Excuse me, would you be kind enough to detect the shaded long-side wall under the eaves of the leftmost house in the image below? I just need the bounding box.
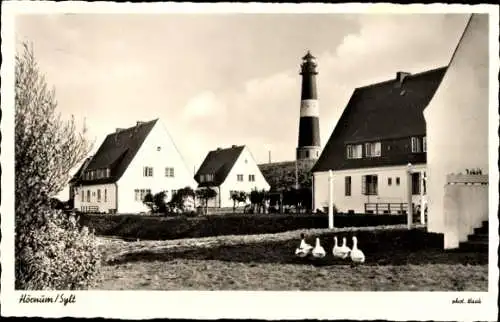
[74,183,116,213]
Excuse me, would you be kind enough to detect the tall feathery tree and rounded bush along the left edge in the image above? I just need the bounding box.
[14,43,100,290]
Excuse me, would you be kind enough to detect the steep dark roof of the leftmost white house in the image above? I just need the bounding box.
[72,119,158,185]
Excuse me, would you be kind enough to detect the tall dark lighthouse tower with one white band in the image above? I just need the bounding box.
[297,51,321,160]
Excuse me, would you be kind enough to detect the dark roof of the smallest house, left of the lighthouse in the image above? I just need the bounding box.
[194,145,245,187]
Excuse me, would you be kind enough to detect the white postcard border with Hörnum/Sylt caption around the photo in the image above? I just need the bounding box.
[0,1,499,321]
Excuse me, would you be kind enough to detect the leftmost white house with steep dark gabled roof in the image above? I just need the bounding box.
[70,119,196,213]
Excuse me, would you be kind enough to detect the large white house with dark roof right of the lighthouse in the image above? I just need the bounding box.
[311,67,446,214]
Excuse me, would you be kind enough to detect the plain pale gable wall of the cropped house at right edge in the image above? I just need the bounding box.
[424,14,490,248]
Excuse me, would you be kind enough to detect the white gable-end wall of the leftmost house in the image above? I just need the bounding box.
[118,122,196,213]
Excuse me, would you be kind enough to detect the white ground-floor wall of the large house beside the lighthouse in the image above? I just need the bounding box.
[313,164,426,213]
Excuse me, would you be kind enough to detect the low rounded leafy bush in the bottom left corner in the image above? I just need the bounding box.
[16,208,101,290]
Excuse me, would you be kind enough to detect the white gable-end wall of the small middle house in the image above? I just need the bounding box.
[220,147,270,207]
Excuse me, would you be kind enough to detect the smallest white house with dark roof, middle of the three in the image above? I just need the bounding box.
[195,145,270,208]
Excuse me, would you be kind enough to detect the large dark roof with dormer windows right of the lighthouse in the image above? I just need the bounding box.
[312,67,447,172]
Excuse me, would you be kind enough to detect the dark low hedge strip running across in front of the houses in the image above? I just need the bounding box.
[80,214,406,240]
